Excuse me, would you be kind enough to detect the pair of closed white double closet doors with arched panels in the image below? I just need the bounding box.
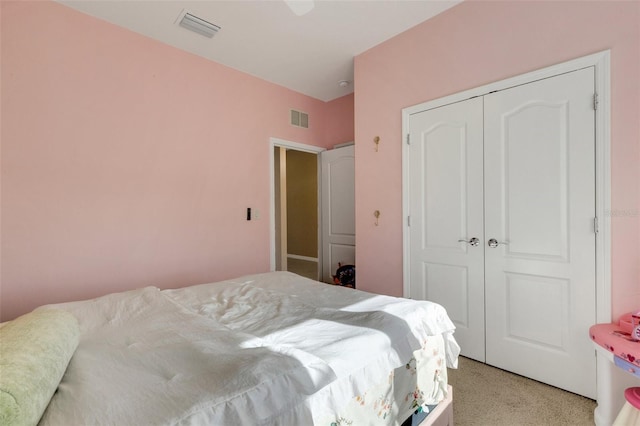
[408,67,596,398]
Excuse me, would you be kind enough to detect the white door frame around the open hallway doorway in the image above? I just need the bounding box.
[269,138,326,271]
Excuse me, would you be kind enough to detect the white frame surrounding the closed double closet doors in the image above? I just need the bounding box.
[402,50,612,322]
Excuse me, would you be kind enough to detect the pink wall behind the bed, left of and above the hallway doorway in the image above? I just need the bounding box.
[0,1,353,320]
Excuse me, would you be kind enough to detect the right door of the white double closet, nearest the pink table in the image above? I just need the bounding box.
[484,67,596,398]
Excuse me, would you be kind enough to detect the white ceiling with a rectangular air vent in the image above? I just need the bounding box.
[57,0,461,101]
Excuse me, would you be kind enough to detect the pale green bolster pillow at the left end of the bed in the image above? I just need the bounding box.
[0,309,80,425]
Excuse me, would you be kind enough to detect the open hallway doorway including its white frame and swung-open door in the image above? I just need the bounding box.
[270,138,355,283]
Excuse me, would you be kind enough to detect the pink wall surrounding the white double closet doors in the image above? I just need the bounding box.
[355,1,640,317]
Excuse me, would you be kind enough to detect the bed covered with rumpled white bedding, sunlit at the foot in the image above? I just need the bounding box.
[0,272,459,426]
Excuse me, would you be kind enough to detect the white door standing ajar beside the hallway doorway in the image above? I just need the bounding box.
[320,145,357,286]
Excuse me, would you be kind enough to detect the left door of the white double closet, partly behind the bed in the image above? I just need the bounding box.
[408,98,485,361]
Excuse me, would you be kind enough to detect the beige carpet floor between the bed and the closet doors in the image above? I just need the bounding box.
[448,357,596,426]
